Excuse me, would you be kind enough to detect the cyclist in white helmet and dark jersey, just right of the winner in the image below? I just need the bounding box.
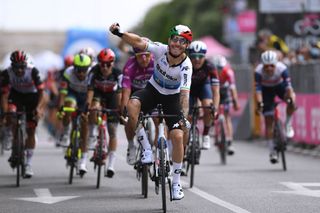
[188,41,220,149]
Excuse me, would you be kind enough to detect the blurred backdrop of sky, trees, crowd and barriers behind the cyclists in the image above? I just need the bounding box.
[0,0,320,147]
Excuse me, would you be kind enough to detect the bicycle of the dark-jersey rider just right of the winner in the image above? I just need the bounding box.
[185,101,215,188]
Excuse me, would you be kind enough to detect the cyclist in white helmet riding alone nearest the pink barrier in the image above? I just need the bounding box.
[255,50,296,163]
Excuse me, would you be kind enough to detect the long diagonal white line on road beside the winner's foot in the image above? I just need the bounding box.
[181,181,250,213]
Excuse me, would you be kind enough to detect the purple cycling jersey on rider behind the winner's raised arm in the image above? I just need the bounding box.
[122,56,154,90]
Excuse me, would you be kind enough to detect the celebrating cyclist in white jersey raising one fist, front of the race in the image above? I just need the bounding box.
[110,23,192,200]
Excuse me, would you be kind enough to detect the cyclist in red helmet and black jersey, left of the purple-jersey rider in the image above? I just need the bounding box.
[86,48,122,178]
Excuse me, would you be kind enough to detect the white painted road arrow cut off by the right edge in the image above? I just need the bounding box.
[274,182,320,197]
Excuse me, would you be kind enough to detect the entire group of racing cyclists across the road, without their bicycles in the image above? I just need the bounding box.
[0,23,295,200]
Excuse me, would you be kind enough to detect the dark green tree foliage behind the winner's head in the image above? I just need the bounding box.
[135,0,224,43]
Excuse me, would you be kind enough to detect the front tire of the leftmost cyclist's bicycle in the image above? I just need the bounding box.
[13,128,24,187]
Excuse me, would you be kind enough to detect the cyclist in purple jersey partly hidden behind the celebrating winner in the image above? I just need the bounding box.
[120,38,154,165]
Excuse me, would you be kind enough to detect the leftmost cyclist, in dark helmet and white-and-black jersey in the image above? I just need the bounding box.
[1,50,45,178]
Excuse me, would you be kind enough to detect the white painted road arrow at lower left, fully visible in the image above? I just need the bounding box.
[13,188,79,204]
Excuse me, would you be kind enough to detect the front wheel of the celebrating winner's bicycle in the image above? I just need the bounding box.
[159,138,167,212]
